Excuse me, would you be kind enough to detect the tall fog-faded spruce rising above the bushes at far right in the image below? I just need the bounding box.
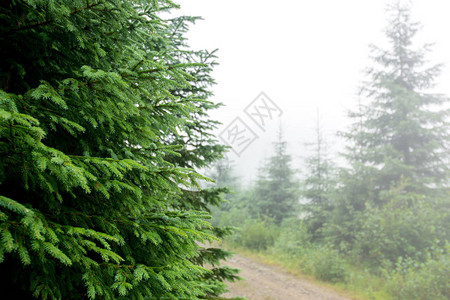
[346,2,449,201]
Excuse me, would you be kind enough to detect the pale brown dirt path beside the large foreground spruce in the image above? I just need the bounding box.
[224,254,351,300]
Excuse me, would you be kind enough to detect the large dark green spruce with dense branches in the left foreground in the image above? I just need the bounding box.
[0,0,239,299]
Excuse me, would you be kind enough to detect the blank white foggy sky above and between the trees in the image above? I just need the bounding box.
[177,0,450,181]
